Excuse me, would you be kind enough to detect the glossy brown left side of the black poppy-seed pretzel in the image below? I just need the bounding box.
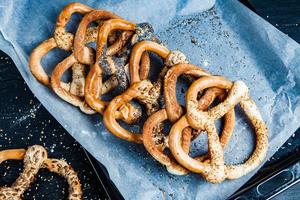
[85,19,154,113]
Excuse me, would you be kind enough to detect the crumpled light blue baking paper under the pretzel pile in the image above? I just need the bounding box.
[0,0,300,199]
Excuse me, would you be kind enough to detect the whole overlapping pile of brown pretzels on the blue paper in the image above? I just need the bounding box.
[29,3,268,183]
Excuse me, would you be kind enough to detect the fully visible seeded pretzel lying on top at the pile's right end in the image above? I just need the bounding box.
[169,76,268,182]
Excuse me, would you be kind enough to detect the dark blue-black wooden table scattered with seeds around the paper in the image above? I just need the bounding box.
[0,0,300,200]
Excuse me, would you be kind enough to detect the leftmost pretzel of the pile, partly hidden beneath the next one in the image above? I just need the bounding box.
[29,3,93,85]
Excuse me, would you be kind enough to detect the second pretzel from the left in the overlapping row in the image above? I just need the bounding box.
[51,10,136,114]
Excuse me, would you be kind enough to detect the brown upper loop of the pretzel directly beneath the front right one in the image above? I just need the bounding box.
[164,63,210,122]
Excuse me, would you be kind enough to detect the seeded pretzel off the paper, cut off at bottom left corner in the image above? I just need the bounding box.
[0,145,82,200]
